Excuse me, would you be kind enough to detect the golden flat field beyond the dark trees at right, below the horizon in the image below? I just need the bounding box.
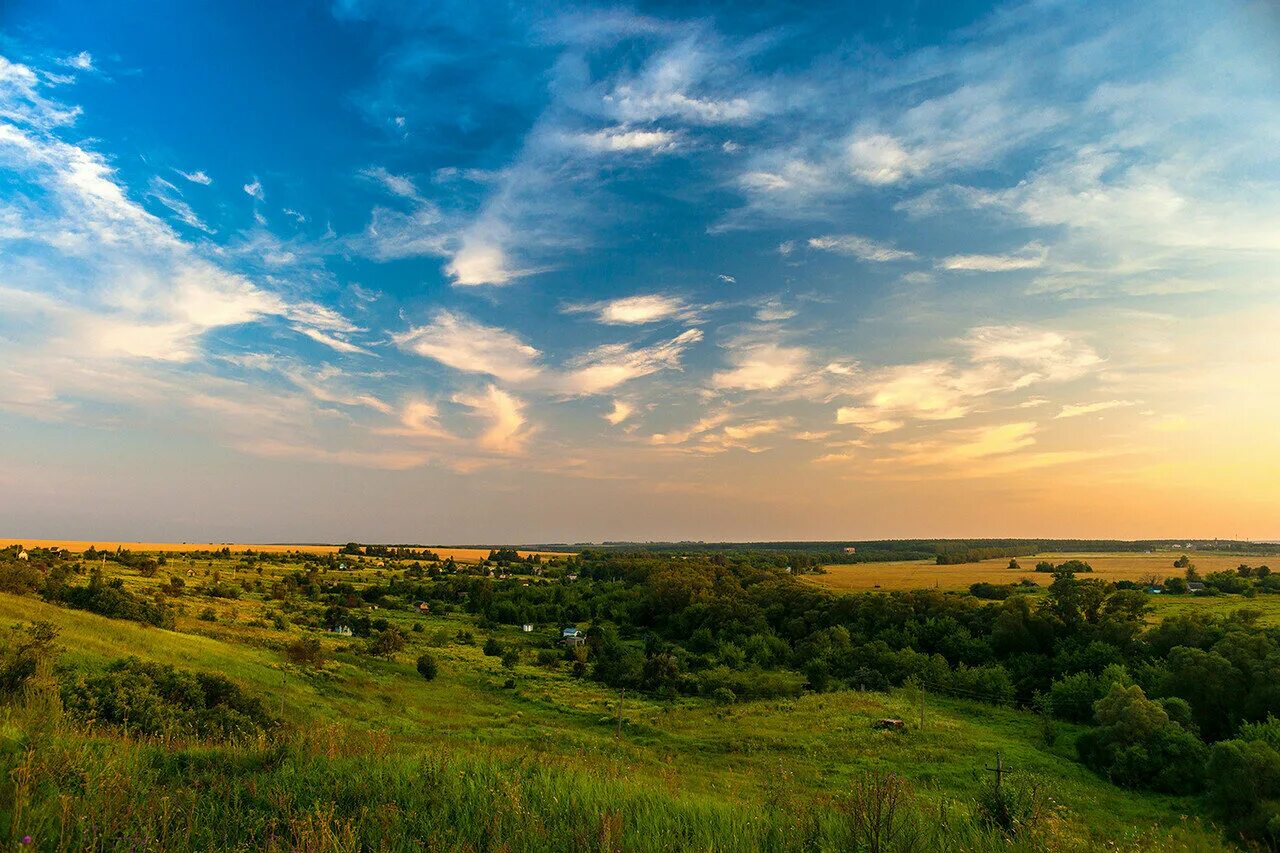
[801,551,1280,592]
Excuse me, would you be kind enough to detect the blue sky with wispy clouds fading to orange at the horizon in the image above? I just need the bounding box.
[0,0,1280,544]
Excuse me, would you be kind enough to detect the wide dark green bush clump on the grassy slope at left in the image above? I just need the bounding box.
[63,657,276,738]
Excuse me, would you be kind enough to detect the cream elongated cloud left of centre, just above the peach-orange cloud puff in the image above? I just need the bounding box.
[392,310,541,382]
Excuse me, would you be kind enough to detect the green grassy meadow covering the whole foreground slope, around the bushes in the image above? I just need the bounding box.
[0,540,1259,850]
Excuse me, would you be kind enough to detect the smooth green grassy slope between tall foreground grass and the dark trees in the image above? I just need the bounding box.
[0,589,1216,848]
